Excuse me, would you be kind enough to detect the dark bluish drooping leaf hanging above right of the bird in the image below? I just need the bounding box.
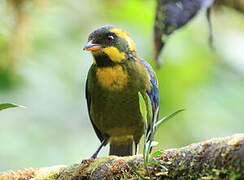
[154,0,216,67]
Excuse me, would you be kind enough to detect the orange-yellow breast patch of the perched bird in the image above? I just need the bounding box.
[96,65,128,91]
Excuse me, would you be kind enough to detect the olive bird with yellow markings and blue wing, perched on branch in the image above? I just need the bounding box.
[83,25,159,159]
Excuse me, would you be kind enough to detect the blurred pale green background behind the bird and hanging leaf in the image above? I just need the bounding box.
[0,0,244,171]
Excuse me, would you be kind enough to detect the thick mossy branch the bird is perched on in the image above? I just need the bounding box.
[0,134,244,180]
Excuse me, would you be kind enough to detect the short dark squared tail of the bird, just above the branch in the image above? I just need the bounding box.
[109,141,133,156]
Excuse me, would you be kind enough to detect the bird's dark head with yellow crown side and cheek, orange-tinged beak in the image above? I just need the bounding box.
[84,26,136,66]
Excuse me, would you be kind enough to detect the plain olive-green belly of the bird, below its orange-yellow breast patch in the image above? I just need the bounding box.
[92,92,144,137]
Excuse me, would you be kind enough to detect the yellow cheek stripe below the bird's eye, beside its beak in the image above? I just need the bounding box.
[102,46,126,62]
